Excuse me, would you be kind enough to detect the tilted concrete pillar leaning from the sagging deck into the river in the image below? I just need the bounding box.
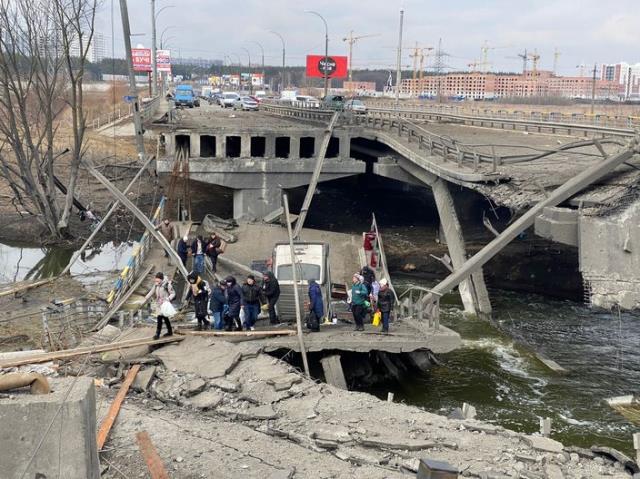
[430,178,491,315]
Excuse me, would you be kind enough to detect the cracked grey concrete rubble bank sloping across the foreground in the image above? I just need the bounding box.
[90,331,633,479]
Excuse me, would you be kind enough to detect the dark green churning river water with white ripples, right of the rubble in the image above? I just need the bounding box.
[378,280,640,454]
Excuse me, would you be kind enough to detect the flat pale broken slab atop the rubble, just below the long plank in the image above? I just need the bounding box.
[153,336,242,379]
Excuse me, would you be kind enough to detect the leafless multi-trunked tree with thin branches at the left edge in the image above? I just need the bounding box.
[0,0,97,237]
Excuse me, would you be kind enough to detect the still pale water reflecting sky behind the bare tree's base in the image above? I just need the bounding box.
[0,242,135,284]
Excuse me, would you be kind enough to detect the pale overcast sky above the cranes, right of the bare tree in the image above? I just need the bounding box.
[97,0,640,75]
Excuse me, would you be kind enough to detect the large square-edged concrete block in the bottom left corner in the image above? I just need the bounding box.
[0,376,100,479]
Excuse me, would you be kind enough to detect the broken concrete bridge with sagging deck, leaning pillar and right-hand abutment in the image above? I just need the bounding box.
[149,105,640,312]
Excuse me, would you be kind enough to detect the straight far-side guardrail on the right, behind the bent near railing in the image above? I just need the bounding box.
[368,107,634,137]
